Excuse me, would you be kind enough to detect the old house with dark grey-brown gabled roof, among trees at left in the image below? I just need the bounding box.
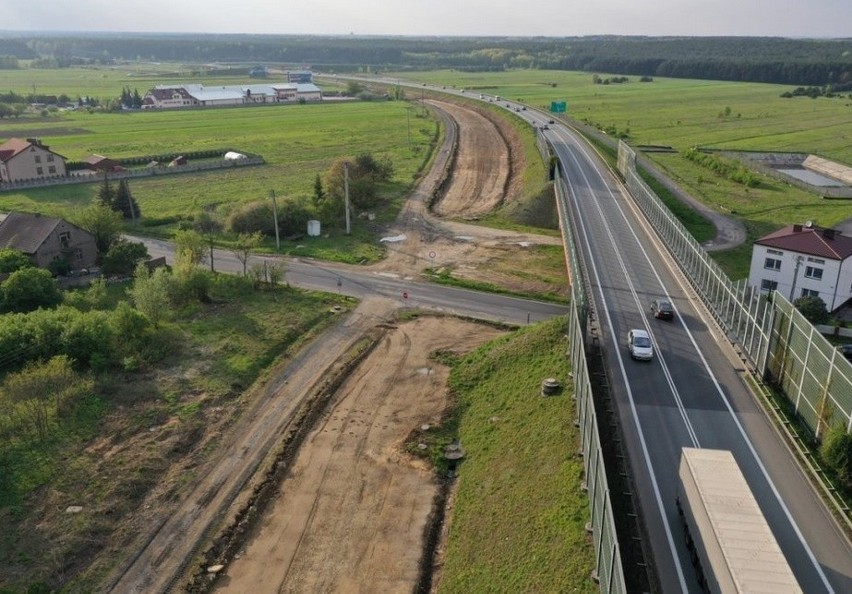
[0,212,98,270]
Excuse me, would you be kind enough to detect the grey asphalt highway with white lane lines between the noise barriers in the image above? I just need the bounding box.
[540,112,852,593]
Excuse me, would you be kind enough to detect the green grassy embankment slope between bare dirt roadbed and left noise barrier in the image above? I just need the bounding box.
[439,319,597,593]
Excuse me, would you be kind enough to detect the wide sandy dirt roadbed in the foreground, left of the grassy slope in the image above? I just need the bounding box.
[217,318,499,594]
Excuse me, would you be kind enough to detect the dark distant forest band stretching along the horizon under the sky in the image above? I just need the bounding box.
[0,32,852,90]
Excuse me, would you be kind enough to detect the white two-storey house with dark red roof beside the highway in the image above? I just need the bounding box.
[748,222,852,312]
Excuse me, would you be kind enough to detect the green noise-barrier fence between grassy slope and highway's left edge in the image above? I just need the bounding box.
[554,163,627,593]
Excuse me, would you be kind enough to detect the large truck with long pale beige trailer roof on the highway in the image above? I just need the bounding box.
[677,448,802,594]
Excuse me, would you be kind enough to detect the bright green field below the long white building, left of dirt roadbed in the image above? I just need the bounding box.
[0,102,437,222]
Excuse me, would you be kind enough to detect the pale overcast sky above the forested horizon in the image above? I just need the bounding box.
[5,0,852,37]
